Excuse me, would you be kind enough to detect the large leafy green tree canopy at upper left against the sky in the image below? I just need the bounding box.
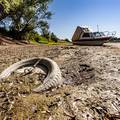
[0,0,52,39]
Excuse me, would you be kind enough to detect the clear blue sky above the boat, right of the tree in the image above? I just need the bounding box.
[49,0,120,39]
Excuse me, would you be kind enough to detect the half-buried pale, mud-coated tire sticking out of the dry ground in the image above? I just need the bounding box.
[0,57,63,92]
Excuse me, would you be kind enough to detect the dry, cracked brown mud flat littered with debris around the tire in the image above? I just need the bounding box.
[0,45,120,120]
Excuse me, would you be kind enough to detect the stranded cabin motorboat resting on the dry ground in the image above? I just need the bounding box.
[72,26,112,46]
